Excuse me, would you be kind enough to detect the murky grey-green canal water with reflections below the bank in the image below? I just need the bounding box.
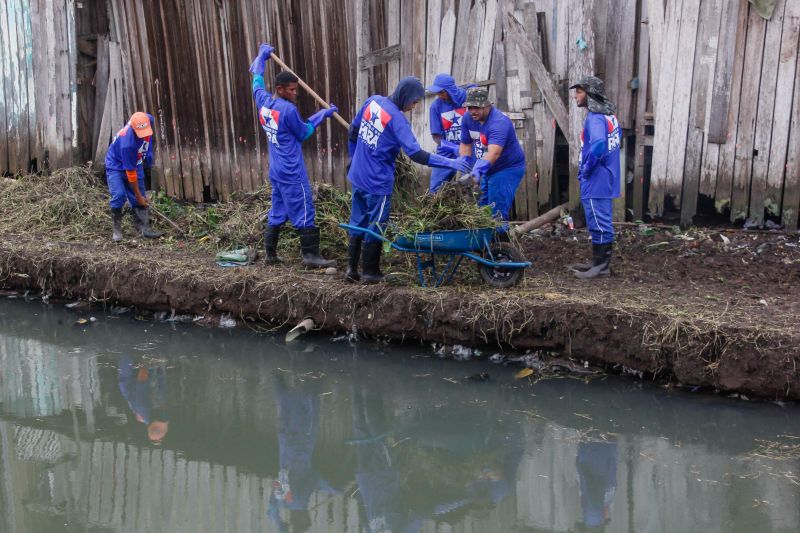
[0,299,800,533]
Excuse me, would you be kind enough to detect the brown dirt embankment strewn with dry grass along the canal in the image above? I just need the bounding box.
[0,228,800,399]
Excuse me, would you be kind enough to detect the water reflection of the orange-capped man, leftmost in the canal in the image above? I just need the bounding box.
[119,355,169,445]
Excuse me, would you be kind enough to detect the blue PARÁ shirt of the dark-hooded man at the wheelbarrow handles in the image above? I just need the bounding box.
[347,95,421,195]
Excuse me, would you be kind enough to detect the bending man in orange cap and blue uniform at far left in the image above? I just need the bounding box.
[105,111,162,242]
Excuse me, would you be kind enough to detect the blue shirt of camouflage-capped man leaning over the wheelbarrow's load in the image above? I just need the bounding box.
[461,107,525,176]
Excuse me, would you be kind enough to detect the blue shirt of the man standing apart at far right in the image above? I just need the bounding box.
[578,113,621,198]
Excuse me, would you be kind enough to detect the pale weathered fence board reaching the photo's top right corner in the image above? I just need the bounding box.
[754,2,800,215]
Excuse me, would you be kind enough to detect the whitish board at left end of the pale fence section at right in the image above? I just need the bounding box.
[648,0,680,217]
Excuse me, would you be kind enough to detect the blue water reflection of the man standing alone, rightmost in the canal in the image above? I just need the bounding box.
[575,441,617,530]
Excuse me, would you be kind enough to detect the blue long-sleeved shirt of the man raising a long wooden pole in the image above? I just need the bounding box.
[253,76,314,183]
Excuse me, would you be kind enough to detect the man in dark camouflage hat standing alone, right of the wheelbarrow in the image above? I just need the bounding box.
[569,76,621,279]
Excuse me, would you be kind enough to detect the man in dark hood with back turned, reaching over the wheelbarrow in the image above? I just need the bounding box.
[345,77,469,283]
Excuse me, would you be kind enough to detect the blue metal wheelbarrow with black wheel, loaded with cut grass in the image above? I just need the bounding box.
[339,224,531,288]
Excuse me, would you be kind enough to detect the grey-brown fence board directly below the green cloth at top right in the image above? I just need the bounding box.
[731,9,767,222]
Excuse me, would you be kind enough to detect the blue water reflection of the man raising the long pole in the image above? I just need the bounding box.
[268,375,332,531]
